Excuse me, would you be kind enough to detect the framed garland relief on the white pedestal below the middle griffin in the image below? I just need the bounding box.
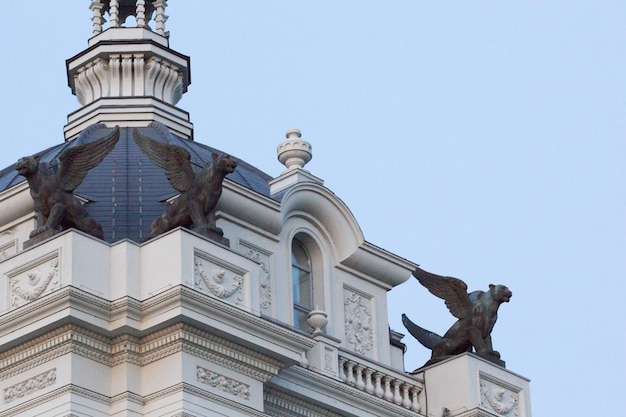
[194,253,244,305]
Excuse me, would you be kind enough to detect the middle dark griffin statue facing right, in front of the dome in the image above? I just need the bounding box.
[133,129,237,237]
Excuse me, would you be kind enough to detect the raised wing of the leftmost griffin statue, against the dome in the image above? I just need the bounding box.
[57,126,120,192]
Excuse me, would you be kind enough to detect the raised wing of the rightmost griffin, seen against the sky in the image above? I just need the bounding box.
[413,268,472,319]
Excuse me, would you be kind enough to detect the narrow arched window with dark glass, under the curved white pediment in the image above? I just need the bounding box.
[291,239,313,331]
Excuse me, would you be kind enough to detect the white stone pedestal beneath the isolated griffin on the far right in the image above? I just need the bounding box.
[416,353,531,417]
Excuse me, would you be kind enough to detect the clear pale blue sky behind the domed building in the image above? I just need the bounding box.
[0,0,626,417]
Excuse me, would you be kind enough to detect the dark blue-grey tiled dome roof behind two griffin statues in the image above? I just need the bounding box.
[0,123,272,242]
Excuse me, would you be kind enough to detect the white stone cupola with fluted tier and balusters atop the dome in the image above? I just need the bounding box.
[64,0,193,140]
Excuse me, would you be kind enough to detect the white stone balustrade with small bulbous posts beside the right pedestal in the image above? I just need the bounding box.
[339,352,423,412]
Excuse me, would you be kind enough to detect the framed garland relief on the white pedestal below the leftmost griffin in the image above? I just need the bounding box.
[7,252,61,308]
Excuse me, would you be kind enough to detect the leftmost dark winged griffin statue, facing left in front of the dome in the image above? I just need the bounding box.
[15,126,120,239]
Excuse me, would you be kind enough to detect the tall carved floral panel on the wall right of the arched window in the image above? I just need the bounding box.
[343,288,374,355]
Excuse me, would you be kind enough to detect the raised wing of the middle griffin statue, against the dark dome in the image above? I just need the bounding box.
[133,129,195,193]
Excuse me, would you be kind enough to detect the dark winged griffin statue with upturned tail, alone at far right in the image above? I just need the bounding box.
[402,268,513,366]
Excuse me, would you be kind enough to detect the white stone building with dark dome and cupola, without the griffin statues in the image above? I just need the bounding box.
[0,0,531,417]
